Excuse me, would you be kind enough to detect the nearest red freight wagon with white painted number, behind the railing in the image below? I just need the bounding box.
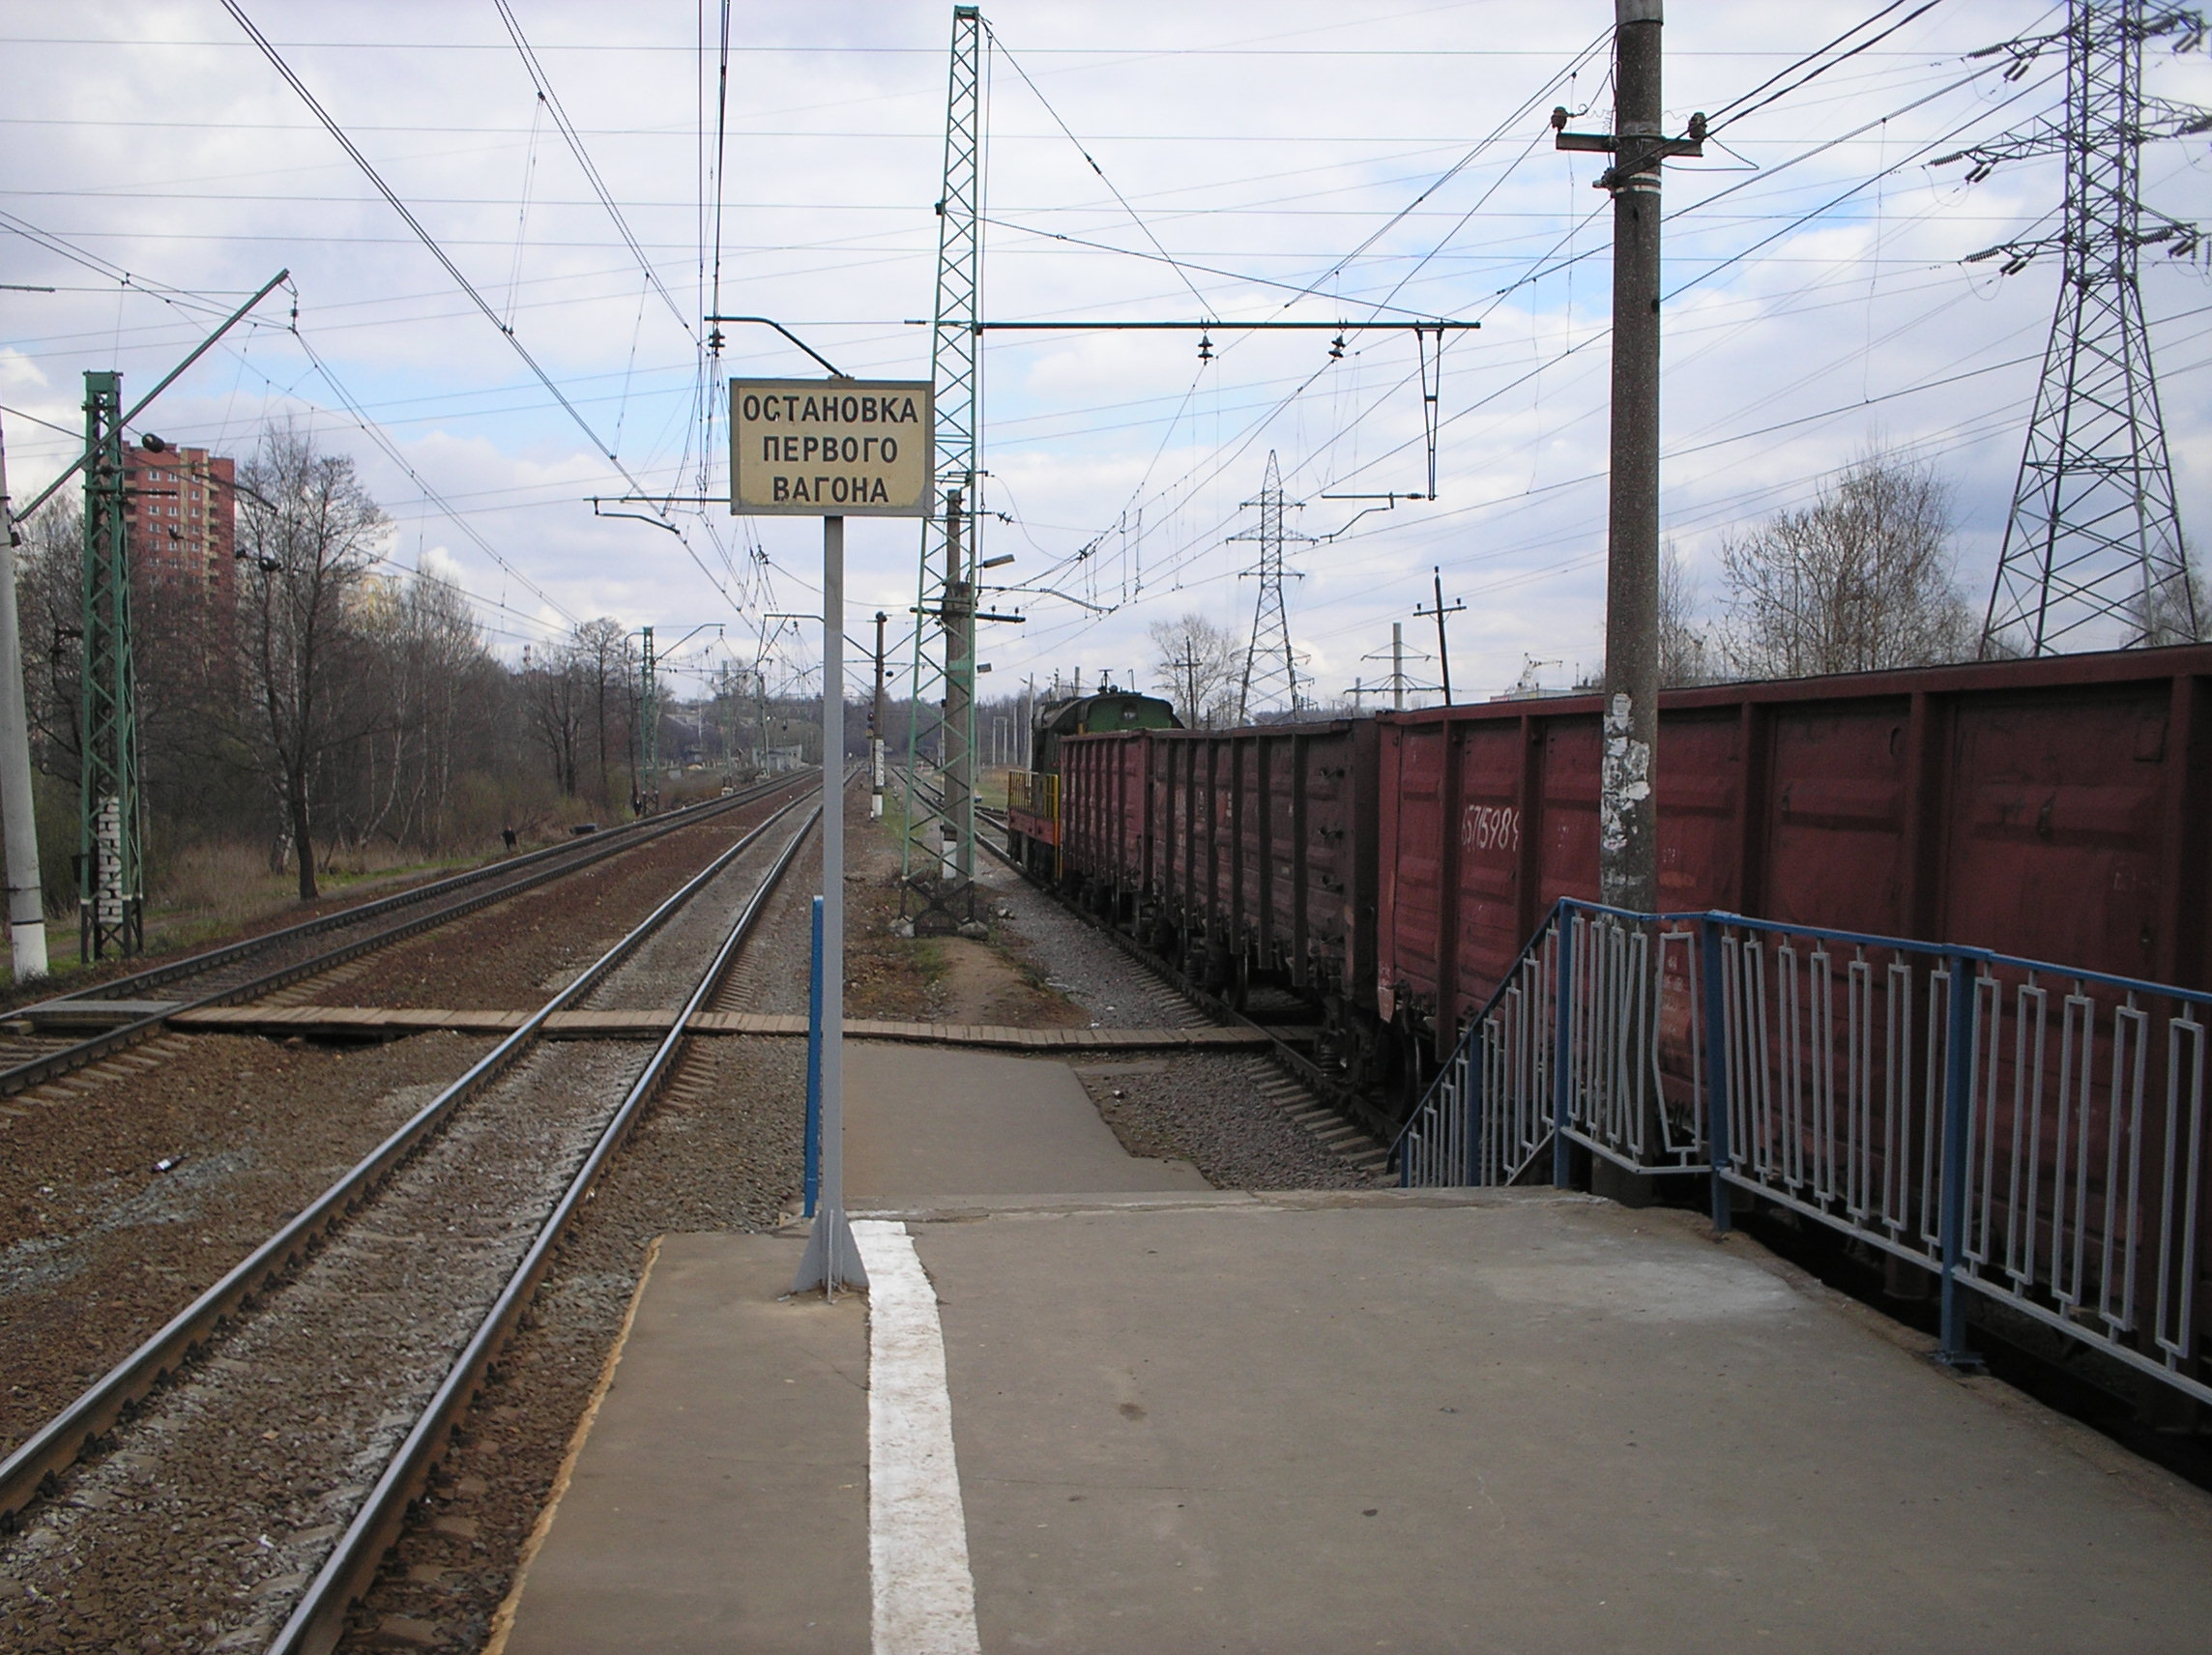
[1376,646,2212,1047]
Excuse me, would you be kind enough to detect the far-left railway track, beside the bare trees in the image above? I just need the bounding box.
[0,776,803,1095]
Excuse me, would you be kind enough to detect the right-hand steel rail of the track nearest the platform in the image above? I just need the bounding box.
[268,805,821,1655]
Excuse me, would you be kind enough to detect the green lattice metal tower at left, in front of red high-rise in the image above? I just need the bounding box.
[77,372,146,963]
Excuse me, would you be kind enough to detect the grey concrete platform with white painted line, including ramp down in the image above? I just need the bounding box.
[493,1044,2212,1655]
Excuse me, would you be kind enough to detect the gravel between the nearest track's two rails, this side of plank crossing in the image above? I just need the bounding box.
[0,1042,651,1655]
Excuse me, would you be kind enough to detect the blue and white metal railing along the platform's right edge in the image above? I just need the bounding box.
[1393,901,2212,1401]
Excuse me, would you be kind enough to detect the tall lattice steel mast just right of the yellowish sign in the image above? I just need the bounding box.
[900,7,984,916]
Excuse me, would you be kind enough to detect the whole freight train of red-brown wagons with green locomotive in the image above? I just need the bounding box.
[1008,646,2212,1116]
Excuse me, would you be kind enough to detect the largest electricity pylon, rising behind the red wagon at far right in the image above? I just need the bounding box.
[1937,0,2212,657]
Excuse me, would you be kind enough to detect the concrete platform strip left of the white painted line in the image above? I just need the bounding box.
[491,1234,869,1655]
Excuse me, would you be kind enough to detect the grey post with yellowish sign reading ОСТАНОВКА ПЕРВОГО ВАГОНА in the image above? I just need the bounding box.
[730,378,936,1296]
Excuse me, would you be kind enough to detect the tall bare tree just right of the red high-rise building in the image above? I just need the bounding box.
[237,422,387,901]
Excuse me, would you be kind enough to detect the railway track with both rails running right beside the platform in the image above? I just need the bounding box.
[0,783,819,1650]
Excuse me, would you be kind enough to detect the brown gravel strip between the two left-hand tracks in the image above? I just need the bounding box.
[0,801,809,1447]
